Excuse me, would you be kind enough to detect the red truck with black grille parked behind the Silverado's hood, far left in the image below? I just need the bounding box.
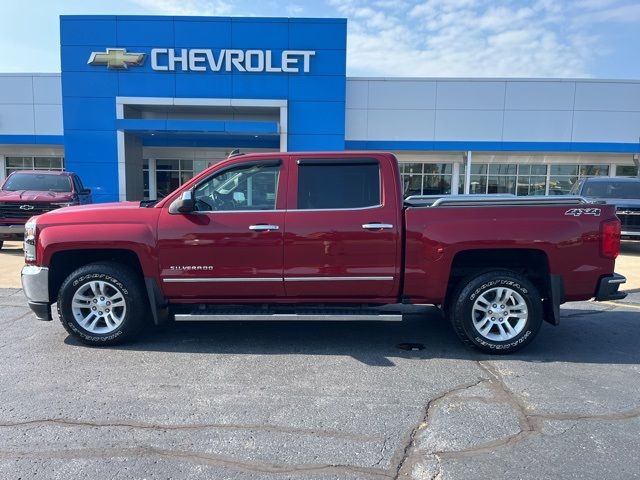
[0,170,91,248]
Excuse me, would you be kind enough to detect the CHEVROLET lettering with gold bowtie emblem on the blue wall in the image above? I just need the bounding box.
[88,48,316,73]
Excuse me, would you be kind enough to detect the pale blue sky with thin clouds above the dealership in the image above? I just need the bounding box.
[0,0,640,79]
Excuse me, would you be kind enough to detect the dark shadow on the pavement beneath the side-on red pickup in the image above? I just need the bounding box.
[65,304,640,367]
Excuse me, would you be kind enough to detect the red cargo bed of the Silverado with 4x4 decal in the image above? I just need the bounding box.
[404,196,615,303]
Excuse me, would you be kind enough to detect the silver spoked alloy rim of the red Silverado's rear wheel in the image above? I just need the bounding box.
[471,287,529,342]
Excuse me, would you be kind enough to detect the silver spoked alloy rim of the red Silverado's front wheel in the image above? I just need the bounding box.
[71,280,127,334]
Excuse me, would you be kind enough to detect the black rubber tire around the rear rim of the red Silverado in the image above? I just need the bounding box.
[449,270,542,354]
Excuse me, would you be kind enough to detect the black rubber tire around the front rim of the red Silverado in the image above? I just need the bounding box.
[58,262,149,346]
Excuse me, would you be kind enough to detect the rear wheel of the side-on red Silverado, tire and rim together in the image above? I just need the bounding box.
[449,270,542,354]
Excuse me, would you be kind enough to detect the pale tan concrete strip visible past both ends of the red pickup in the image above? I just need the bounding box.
[0,242,640,290]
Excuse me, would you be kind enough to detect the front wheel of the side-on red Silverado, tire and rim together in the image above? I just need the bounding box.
[58,262,147,345]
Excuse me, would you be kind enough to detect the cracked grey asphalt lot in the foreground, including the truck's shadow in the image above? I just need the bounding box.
[0,289,640,479]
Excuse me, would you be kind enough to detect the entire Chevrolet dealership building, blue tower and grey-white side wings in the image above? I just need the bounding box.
[0,16,640,202]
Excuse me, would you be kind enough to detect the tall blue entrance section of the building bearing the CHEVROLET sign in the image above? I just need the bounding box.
[60,16,346,201]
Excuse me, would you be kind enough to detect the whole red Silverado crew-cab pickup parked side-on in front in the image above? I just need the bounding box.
[22,152,625,353]
